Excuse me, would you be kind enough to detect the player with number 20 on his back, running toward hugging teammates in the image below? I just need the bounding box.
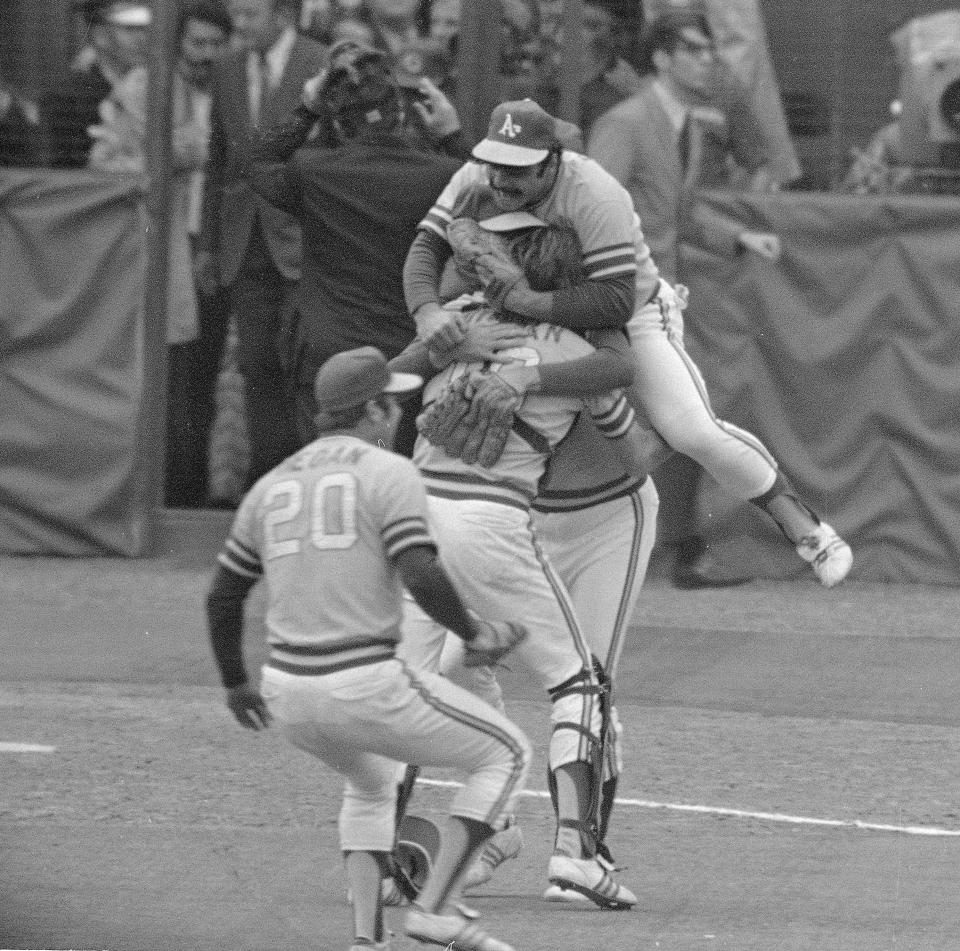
[207,347,530,951]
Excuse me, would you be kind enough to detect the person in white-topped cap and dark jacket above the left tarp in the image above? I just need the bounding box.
[40,0,151,168]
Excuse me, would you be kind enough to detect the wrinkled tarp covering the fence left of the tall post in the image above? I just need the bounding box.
[0,169,149,555]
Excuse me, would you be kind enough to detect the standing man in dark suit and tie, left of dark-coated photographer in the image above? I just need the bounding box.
[198,0,326,484]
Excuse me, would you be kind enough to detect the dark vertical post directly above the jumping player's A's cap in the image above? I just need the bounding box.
[457,0,503,145]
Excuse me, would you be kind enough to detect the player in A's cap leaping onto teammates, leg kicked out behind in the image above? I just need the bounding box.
[404,99,853,587]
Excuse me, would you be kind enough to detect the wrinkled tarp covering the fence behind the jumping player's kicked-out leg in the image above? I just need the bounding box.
[672,193,960,584]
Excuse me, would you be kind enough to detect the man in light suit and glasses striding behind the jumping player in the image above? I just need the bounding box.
[588,10,812,588]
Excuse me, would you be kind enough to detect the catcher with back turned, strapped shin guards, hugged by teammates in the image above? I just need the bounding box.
[393,216,646,909]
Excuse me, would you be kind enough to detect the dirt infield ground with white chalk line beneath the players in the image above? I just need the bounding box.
[0,528,960,951]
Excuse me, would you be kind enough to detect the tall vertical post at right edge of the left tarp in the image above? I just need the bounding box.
[138,0,177,548]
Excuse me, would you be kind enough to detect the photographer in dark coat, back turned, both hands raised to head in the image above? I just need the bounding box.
[247,41,461,455]
